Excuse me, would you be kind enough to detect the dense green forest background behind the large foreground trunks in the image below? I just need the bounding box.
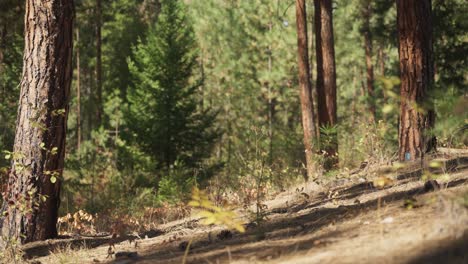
[0,0,468,225]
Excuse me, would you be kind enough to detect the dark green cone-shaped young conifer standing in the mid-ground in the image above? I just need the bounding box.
[127,0,217,173]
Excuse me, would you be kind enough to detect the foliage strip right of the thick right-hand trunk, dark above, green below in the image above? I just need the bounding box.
[431,0,468,147]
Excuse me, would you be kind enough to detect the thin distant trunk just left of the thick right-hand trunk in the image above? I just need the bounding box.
[362,0,376,122]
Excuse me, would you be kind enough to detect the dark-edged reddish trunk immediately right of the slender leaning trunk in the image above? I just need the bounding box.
[314,0,338,169]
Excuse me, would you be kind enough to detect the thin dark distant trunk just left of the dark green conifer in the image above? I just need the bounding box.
[96,0,104,127]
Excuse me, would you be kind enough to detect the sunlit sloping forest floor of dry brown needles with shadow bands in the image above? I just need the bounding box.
[25,152,468,263]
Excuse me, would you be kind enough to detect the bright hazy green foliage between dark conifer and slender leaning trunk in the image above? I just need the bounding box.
[189,0,303,179]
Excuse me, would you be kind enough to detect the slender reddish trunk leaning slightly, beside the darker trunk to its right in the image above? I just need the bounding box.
[296,0,316,179]
